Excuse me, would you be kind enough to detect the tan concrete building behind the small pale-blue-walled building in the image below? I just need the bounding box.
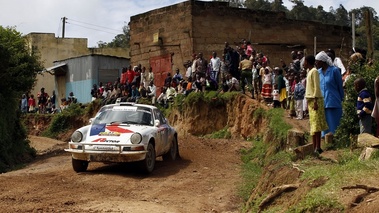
[25,33,130,103]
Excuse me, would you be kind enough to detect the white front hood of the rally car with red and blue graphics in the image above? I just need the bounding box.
[87,124,152,143]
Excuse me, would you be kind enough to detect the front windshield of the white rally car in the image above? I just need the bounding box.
[93,106,153,126]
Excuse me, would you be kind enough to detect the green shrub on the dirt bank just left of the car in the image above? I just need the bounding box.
[42,104,85,138]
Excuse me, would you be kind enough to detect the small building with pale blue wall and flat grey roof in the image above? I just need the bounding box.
[45,54,130,104]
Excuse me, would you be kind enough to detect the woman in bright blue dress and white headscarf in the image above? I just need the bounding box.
[316,51,344,137]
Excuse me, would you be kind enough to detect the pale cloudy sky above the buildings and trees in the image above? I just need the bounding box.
[0,0,379,47]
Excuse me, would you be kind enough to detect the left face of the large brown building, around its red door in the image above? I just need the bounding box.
[130,2,193,70]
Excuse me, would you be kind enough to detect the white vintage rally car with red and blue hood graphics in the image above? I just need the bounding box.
[65,103,179,173]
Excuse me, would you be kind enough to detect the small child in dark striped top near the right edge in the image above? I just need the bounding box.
[354,78,373,134]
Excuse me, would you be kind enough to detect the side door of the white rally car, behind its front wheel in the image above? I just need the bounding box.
[154,109,170,155]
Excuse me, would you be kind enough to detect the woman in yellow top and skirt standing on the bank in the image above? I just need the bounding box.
[303,55,328,154]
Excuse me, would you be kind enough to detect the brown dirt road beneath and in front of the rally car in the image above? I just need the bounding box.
[0,136,250,213]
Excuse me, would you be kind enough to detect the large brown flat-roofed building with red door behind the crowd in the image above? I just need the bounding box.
[129,0,351,91]
